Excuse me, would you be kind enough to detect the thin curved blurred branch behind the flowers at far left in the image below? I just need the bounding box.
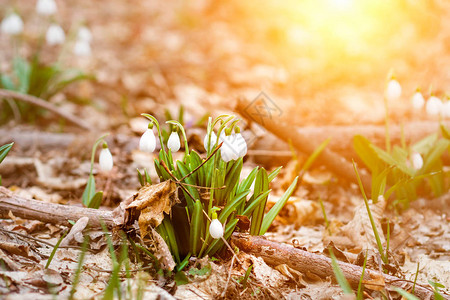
[0,89,91,130]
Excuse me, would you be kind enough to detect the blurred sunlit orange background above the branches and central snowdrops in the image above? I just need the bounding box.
[0,0,450,128]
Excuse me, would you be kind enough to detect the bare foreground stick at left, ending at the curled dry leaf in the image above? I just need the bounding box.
[0,186,116,228]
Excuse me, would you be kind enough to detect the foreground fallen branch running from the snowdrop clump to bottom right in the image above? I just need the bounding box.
[231,233,450,299]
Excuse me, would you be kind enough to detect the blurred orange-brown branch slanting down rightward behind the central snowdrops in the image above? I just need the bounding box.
[236,101,372,191]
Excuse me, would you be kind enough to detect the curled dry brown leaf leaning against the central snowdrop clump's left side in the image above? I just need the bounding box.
[126,180,180,237]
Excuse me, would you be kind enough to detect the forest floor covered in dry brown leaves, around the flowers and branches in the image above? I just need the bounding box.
[0,0,450,299]
